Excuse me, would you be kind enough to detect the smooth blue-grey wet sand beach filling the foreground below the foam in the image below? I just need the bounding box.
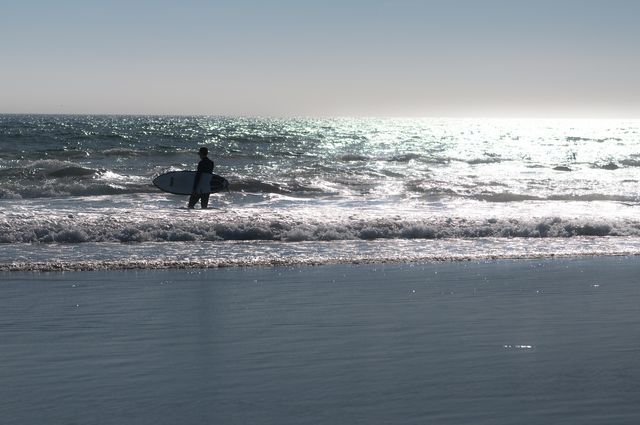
[0,257,640,425]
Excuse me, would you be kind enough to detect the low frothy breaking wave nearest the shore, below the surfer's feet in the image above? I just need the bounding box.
[0,212,640,243]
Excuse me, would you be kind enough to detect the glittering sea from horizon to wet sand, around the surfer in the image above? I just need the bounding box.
[0,115,640,270]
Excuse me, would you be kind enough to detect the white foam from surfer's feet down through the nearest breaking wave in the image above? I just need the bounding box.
[0,196,640,243]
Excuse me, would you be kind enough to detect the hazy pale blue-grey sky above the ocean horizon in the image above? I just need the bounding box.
[0,0,640,118]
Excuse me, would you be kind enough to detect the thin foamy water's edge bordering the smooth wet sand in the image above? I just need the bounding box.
[0,251,640,274]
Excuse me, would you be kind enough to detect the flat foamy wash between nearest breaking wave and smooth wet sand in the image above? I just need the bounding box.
[0,237,640,271]
